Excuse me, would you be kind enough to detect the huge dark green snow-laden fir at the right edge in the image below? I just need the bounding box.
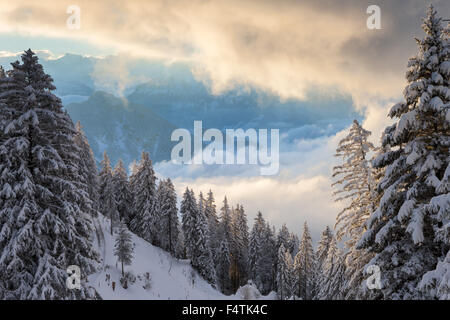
[359,6,450,299]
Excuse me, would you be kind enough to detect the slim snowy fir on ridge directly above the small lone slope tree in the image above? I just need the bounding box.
[112,159,133,222]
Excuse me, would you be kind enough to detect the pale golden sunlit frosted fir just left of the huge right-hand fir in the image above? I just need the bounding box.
[333,120,376,299]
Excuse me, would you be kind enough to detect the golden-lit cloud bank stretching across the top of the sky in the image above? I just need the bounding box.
[0,0,450,104]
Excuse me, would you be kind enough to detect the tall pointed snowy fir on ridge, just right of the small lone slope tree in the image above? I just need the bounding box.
[130,152,158,243]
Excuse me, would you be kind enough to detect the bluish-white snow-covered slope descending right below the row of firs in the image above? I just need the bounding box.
[88,215,274,300]
